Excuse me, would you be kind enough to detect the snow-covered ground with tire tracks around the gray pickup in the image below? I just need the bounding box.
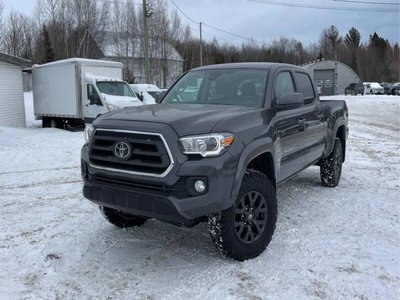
[0,95,400,299]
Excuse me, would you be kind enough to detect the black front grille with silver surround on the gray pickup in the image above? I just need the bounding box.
[89,128,174,177]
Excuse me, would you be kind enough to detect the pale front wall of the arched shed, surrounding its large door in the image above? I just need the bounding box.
[303,60,361,95]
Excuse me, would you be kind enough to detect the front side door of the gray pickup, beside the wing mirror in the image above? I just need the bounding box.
[274,70,305,182]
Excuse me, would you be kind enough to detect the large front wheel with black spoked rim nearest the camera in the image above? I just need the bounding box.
[208,169,278,261]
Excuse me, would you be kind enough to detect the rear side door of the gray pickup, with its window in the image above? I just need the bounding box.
[294,71,327,166]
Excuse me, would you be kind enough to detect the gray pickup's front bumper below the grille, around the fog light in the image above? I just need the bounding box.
[81,146,237,225]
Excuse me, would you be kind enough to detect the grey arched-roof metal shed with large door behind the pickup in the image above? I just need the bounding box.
[302,60,361,95]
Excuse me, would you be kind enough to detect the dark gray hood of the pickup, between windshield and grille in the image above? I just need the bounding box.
[99,104,258,136]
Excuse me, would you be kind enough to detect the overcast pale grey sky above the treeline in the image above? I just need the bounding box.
[4,0,400,45]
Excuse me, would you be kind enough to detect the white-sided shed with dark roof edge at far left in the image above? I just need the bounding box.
[0,53,31,127]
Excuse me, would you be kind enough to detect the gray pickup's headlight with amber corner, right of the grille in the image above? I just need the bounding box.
[179,133,234,157]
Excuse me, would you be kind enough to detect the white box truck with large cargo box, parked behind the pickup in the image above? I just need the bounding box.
[32,58,146,128]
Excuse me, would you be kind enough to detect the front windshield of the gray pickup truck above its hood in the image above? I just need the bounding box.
[162,69,268,107]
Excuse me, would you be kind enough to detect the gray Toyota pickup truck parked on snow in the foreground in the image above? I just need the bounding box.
[81,63,348,261]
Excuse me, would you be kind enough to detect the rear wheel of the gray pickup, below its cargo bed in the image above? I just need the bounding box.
[320,138,343,187]
